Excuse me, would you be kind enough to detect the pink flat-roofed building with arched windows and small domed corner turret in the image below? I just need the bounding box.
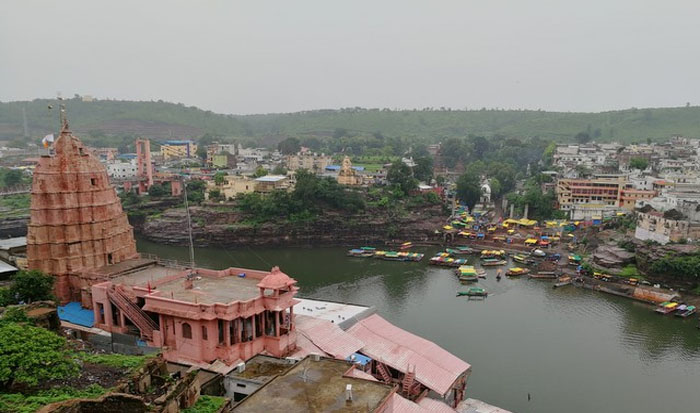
[92,260,298,365]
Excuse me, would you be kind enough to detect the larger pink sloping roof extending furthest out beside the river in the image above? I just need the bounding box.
[347,314,471,395]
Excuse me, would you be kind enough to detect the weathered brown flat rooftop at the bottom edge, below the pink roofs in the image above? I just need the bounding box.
[234,357,392,413]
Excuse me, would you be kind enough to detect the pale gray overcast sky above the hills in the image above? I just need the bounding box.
[0,0,700,113]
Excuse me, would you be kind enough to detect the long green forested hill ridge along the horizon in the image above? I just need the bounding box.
[0,99,700,142]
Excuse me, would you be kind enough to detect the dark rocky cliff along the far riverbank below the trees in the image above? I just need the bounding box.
[139,206,447,247]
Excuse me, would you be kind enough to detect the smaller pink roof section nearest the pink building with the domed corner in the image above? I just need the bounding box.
[294,315,364,360]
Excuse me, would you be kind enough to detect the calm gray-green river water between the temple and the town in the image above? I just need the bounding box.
[138,240,700,413]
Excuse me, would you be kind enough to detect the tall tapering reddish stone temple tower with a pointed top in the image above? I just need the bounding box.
[27,122,137,304]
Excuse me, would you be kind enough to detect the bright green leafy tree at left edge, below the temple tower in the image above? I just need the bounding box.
[0,322,79,389]
